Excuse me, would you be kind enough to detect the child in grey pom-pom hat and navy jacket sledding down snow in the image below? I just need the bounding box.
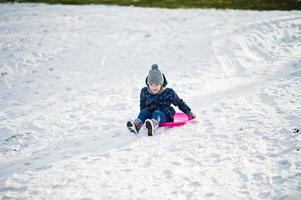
[127,64,196,136]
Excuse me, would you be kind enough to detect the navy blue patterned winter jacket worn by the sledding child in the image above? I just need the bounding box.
[140,87,191,121]
